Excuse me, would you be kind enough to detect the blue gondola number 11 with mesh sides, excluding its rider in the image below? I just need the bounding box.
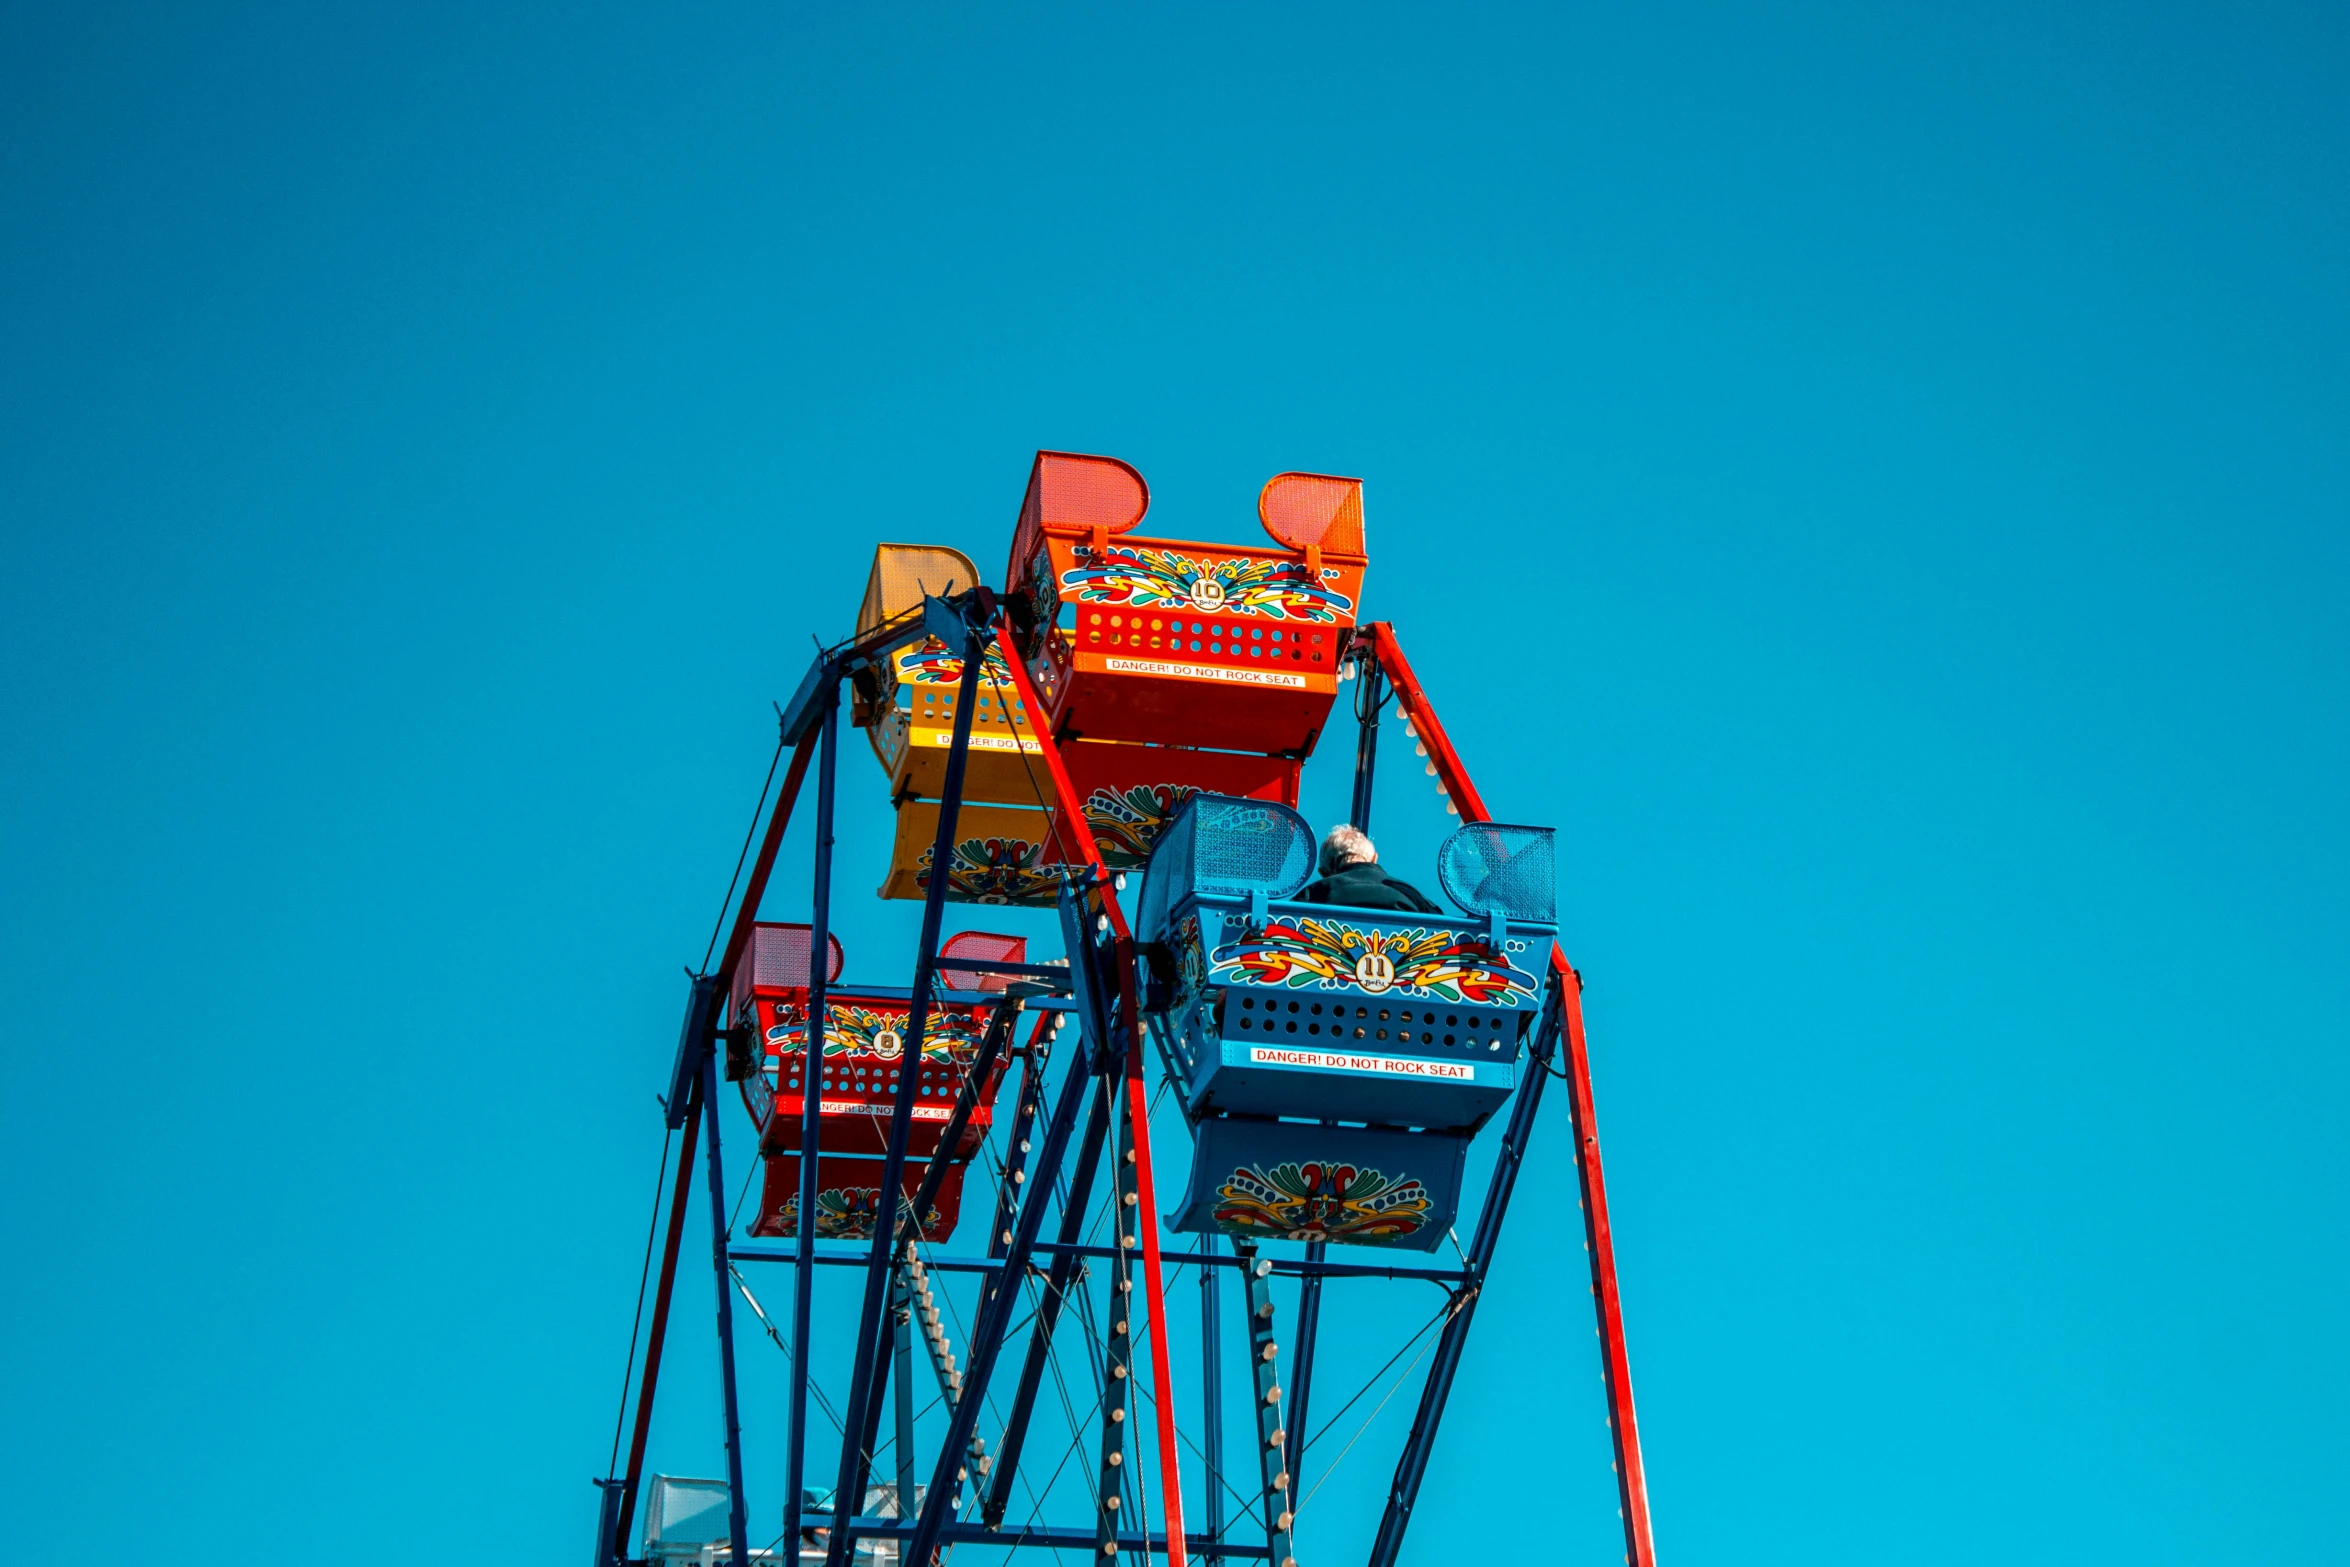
[1137,794,1558,1250]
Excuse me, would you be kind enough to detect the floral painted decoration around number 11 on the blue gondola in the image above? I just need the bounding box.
[1210,914,1537,1006]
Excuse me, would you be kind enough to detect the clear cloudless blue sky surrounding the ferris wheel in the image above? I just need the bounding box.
[0,5,2350,1567]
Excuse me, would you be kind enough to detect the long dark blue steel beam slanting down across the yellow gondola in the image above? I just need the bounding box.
[827,590,994,1567]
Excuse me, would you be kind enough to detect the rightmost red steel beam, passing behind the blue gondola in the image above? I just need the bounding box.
[1358,620,1657,1567]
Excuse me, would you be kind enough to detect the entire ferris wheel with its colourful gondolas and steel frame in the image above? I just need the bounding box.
[595,451,1654,1567]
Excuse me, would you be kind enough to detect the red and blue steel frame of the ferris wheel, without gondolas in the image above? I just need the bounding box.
[595,587,1654,1567]
